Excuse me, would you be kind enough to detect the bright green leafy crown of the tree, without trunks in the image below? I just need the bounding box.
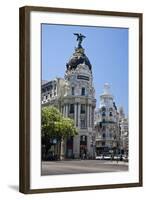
[42,106,77,138]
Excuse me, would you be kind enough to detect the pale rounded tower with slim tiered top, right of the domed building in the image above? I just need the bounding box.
[96,83,120,155]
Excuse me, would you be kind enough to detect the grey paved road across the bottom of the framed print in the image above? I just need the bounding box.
[42,160,128,175]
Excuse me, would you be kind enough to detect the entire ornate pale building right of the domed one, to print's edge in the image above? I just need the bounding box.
[95,83,128,156]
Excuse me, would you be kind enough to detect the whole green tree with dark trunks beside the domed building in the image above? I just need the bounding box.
[41,106,78,161]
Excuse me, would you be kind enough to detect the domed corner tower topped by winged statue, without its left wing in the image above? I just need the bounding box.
[63,34,96,158]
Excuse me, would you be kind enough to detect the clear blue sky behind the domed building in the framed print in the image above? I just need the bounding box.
[42,24,128,114]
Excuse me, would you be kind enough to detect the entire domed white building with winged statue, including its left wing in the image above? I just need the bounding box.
[42,34,96,158]
